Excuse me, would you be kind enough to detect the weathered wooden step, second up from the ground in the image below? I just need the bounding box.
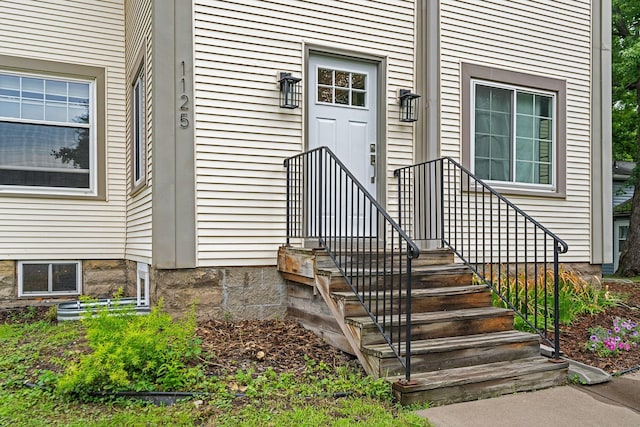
[362,331,540,377]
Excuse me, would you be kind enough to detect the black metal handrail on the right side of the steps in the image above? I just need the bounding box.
[394,157,568,358]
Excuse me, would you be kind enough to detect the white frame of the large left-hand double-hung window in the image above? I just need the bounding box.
[0,69,98,196]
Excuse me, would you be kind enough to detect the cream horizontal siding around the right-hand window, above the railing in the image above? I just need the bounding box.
[440,0,591,262]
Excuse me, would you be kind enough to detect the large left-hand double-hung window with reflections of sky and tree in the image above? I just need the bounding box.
[0,70,97,195]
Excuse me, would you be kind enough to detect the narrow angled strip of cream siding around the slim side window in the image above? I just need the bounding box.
[125,0,153,264]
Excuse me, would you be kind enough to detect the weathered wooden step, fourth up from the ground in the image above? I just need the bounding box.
[331,285,491,317]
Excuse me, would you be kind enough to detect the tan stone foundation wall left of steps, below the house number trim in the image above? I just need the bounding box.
[149,266,287,320]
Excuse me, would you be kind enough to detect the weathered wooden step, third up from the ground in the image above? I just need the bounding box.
[345,307,513,347]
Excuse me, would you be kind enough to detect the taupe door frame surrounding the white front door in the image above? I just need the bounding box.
[302,44,387,209]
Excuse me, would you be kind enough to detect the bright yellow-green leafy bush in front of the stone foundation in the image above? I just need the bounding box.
[57,302,202,395]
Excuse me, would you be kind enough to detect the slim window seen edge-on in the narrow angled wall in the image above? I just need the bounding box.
[131,67,146,191]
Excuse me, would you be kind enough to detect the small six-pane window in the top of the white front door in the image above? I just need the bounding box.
[316,68,367,107]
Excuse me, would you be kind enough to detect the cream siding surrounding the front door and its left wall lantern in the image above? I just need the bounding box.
[194,0,415,266]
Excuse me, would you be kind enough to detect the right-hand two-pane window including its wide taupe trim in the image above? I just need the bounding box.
[462,64,566,197]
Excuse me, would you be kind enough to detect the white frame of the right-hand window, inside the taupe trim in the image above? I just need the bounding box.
[470,79,558,191]
